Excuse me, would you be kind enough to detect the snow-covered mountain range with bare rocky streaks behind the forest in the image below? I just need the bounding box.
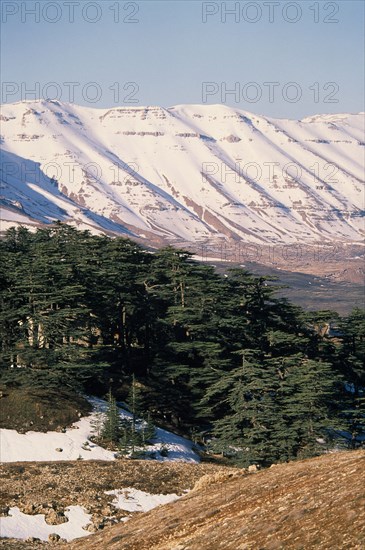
[0,101,365,244]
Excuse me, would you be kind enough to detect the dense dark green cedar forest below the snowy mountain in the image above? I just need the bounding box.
[0,223,365,466]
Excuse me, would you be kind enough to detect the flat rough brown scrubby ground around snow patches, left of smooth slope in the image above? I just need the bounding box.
[0,460,235,550]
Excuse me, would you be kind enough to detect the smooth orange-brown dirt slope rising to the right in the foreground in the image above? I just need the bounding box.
[67,451,365,550]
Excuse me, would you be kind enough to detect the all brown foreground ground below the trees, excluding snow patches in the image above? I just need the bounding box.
[0,451,365,550]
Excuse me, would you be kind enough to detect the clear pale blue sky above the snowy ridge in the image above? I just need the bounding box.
[1,0,364,118]
